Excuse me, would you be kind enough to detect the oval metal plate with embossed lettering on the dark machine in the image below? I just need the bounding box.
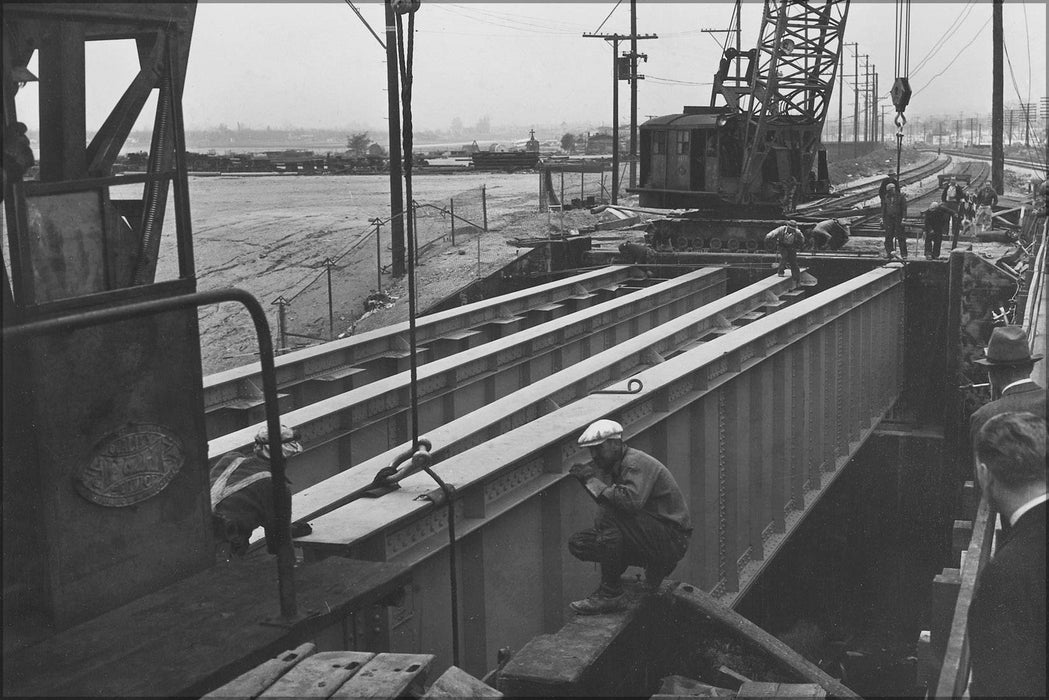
[73,423,186,508]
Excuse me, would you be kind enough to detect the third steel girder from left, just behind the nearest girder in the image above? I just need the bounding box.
[292,268,797,522]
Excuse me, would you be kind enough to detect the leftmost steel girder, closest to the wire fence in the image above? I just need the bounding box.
[204,266,644,439]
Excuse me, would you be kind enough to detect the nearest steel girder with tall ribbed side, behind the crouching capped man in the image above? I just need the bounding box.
[297,267,903,673]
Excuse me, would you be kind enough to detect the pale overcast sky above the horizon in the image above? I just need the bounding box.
[12,0,1046,136]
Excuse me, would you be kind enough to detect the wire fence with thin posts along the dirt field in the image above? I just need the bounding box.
[272,186,489,353]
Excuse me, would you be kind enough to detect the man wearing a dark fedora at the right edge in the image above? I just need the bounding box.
[969,325,1046,445]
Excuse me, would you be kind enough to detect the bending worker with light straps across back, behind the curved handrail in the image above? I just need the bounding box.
[210,425,309,556]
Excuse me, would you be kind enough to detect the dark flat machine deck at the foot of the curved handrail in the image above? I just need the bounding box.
[3,556,410,697]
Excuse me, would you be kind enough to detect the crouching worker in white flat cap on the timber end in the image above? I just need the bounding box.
[569,420,692,615]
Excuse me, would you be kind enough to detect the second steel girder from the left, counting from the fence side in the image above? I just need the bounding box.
[209,269,727,491]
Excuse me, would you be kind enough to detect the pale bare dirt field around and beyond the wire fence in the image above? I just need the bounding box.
[157,148,994,374]
